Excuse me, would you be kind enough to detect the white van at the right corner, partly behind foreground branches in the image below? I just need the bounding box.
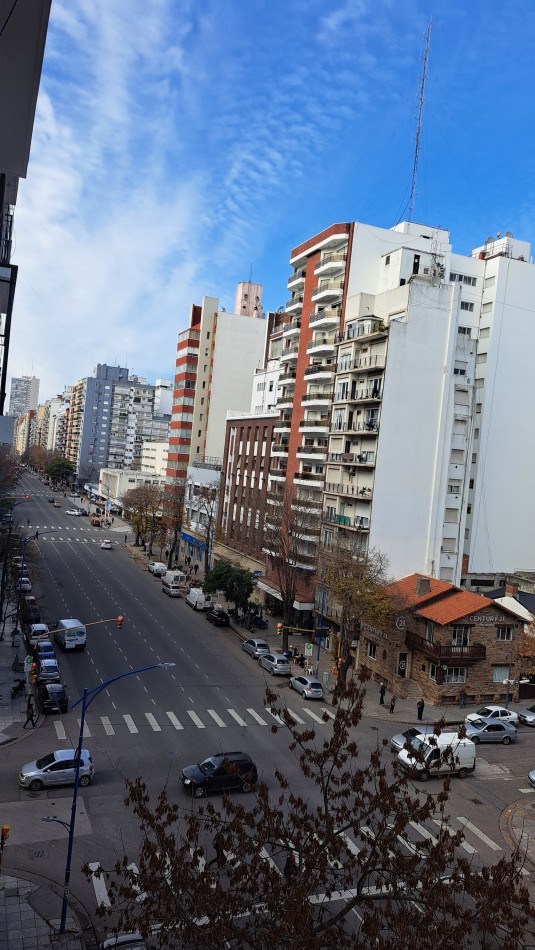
[398,732,476,782]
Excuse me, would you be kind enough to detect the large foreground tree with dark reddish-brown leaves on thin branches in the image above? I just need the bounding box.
[86,680,533,950]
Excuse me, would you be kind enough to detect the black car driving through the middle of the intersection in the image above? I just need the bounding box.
[181,752,258,798]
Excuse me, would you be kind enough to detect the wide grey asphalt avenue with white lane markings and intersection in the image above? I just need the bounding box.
[0,476,535,940]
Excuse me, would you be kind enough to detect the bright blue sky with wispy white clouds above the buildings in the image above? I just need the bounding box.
[9,0,535,400]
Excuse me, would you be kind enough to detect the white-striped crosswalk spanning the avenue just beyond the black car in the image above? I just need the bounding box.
[53,706,335,740]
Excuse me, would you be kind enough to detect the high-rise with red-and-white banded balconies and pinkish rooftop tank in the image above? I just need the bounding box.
[167,281,270,480]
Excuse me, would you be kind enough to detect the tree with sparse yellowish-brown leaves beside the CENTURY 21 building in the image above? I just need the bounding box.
[318,535,400,685]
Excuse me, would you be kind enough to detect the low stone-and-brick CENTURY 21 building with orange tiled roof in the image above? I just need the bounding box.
[358,574,523,705]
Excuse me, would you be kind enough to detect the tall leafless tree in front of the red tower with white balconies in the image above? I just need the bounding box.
[263,485,320,650]
